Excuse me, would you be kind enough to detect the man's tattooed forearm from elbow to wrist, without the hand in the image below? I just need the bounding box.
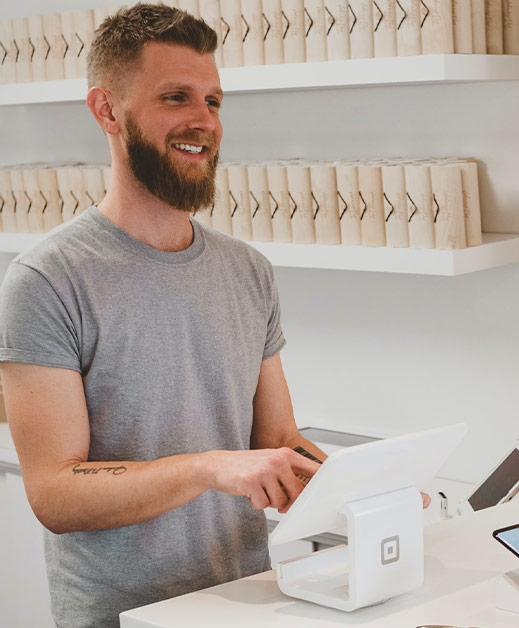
[30,453,210,534]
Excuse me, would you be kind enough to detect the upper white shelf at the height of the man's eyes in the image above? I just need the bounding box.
[0,54,519,105]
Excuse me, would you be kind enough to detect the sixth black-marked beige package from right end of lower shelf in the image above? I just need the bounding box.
[310,165,341,244]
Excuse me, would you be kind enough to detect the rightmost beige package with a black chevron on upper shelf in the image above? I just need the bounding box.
[420,0,454,55]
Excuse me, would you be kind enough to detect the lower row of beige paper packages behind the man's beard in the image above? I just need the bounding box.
[0,158,482,249]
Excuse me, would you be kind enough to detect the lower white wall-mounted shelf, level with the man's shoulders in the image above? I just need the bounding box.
[0,233,519,276]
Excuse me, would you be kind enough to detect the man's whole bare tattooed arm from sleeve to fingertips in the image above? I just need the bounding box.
[0,363,318,534]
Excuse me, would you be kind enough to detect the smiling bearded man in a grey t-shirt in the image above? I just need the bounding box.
[0,4,323,628]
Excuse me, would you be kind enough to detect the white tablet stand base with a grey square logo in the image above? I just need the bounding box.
[277,487,424,611]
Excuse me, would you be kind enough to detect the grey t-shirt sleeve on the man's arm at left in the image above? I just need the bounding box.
[0,261,81,372]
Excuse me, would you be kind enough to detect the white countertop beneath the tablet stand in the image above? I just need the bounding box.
[121,502,519,628]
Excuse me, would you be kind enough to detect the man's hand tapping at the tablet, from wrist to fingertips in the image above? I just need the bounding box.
[206,447,321,513]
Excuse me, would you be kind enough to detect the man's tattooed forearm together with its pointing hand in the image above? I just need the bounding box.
[29,447,324,534]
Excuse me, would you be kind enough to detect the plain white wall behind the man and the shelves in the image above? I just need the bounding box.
[0,0,519,481]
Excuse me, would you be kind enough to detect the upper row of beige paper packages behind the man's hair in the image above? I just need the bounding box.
[0,0,519,83]
